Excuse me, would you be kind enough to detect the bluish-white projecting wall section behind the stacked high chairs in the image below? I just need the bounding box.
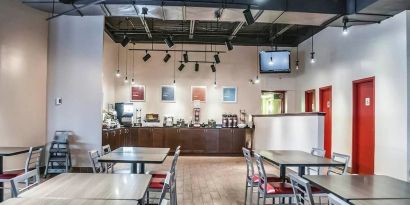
[47,16,104,167]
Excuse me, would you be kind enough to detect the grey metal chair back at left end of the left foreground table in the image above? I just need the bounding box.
[11,168,40,198]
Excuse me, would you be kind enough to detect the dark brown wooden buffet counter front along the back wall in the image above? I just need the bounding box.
[102,127,253,155]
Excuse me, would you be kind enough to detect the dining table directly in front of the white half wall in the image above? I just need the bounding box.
[255,150,345,181]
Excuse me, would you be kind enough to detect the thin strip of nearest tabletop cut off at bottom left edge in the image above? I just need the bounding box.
[1,198,136,205]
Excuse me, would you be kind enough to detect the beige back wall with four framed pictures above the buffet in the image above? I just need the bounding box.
[108,39,296,123]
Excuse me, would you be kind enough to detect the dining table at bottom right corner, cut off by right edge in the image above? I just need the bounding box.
[303,175,410,201]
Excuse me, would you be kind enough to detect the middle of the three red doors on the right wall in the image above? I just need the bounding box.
[319,86,332,158]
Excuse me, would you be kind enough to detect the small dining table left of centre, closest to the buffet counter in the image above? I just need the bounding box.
[98,147,170,174]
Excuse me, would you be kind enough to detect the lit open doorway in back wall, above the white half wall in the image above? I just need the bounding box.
[261,91,286,115]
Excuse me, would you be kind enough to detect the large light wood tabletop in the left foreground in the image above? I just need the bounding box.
[20,173,152,201]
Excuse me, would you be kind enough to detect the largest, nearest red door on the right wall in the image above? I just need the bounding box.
[352,77,375,174]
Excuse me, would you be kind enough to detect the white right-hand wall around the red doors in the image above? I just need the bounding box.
[296,12,408,179]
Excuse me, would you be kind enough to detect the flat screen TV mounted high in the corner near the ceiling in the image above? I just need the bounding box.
[259,51,291,73]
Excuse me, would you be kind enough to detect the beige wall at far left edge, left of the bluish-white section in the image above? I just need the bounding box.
[0,0,48,169]
